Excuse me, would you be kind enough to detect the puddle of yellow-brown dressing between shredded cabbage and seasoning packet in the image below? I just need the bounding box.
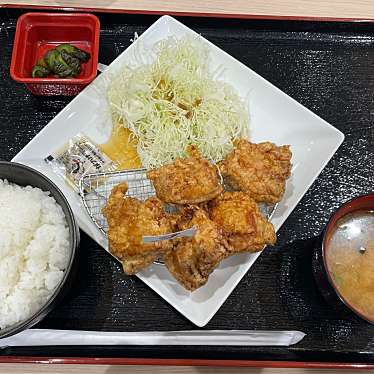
[99,123,142,170]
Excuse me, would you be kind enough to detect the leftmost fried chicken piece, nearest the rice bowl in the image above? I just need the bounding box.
[102,183,173,274]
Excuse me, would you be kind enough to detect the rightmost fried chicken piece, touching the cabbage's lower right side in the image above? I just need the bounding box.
[219,139,292,204]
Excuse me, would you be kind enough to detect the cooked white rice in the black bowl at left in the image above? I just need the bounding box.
[0,179,70,329]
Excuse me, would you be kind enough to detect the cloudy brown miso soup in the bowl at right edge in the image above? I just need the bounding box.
[326,210,374,319]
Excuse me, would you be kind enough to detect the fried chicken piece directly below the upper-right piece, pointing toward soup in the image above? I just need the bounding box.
[209,192,276,254]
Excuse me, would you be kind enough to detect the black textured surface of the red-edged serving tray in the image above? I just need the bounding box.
[0,9,374,363]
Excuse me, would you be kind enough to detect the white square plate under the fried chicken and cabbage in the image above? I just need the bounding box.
[13,16,344,326]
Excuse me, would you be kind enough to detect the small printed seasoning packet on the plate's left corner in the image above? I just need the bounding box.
[44,134,117,192]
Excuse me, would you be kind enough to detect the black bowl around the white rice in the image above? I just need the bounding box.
[0,161,80,341]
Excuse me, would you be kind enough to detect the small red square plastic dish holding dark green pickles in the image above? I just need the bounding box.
[10,13,100,96]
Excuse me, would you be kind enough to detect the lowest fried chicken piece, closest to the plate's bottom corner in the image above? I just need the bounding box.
[164,206,227,291]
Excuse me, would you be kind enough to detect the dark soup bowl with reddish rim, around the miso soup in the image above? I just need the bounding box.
[321,192,374,325]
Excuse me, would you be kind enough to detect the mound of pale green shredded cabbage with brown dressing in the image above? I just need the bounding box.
[107,37,249,169]
